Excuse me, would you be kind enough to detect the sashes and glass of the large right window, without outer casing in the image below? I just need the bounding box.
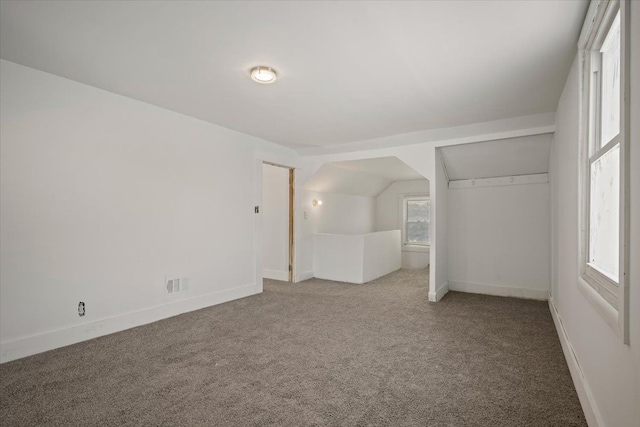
[585,9,620,307]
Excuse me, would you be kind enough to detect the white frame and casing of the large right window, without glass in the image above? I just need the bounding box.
[578,0,629,344]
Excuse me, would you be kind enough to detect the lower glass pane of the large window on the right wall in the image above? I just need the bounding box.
[589,144,620,281]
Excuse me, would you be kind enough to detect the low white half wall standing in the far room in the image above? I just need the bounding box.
[313,230,400,283]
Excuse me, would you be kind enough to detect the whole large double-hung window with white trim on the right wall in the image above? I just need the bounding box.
[580,1,628,342]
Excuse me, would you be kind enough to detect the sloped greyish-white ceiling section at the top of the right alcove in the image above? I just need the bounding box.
[440,134,552,181]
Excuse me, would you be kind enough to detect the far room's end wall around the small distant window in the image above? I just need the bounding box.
[376,179,429,269]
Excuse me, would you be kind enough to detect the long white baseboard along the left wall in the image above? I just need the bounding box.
[0,283,256,363]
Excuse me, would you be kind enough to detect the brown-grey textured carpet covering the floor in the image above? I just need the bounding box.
[0,270,586,427]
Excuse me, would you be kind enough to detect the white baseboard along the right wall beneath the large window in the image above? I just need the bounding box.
[549,296,604,427]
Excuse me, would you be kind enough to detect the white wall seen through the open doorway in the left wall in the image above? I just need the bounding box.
[262,164,289,280]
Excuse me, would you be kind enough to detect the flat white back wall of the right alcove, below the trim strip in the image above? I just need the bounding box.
[448,184,550,300]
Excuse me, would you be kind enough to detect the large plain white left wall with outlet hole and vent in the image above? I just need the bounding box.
[0,60,290,361]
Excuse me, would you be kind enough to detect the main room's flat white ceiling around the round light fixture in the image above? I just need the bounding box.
[0,0,588,148]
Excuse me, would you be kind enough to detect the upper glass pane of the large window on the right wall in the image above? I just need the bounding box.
[600,11,620,147]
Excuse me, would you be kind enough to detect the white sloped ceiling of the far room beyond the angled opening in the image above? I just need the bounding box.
[302,157,425,197]
